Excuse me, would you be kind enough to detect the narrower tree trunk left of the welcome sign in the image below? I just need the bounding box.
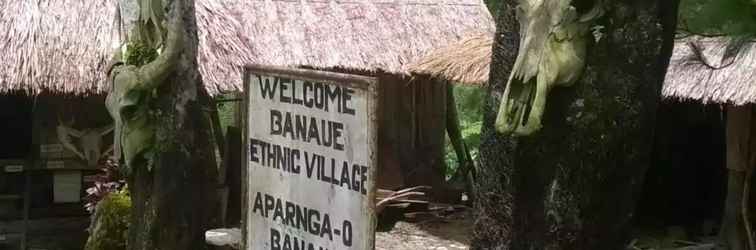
[119,0,217,250]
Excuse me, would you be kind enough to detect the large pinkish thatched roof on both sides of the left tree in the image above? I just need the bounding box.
[0,0,494,94]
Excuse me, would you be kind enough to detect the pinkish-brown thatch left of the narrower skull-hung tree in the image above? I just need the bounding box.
[0,0,115,93]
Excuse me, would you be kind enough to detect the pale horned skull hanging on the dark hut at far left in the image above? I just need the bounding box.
[56,116,113,166]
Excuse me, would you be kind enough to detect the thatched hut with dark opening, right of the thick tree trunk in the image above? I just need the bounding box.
[628,36,756,243]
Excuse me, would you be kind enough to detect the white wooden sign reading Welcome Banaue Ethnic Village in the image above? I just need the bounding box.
[243,66,378,250]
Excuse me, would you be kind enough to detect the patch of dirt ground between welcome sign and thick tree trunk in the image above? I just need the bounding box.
[375,209,473,250]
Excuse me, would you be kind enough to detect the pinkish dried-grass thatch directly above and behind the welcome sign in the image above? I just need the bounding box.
[198,0,494,93]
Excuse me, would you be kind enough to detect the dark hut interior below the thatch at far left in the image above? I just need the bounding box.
[0,93,112,249]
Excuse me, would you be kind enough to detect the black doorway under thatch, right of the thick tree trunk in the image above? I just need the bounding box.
[636,102,726,240]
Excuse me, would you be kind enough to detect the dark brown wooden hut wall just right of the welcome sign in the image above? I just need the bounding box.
[325,68,446,192]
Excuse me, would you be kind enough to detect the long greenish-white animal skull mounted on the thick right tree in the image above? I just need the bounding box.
[496,0,602,135]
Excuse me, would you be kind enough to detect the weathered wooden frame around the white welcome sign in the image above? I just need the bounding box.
[241,65,379,250]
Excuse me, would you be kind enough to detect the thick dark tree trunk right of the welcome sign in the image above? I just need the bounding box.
[473,0,677,250]
